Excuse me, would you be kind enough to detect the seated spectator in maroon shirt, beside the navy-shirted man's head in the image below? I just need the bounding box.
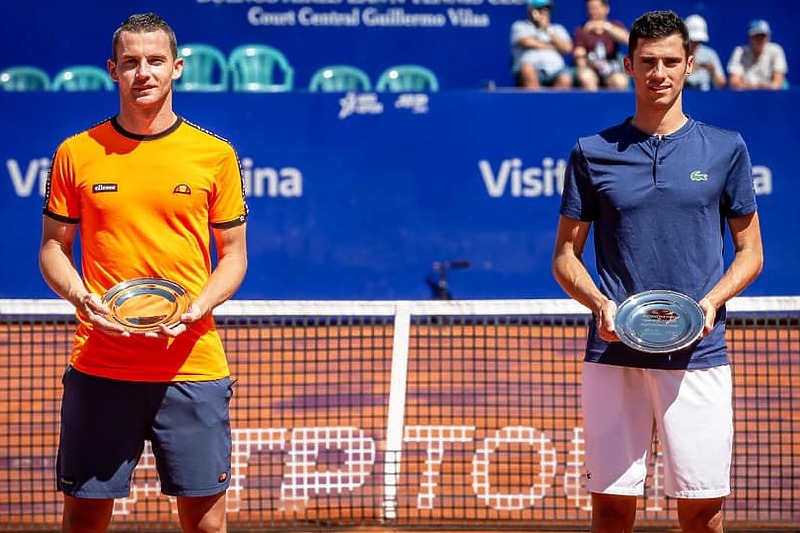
[573,0,628,91]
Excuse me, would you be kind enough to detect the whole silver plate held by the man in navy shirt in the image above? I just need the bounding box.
[614,291,704,354]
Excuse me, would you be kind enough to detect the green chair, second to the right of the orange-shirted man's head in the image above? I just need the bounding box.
[228,44,294,92]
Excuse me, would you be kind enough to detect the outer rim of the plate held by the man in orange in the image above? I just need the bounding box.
[102,277,190,333]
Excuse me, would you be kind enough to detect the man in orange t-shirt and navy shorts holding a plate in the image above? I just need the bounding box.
[39,13,247,532]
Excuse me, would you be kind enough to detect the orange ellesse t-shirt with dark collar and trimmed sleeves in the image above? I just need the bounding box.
[44,118,247,382]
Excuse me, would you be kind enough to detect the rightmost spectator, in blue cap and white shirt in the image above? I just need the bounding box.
[728,19,788,89]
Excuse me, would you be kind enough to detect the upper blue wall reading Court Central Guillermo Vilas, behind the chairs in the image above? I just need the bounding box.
[0,0,800,91]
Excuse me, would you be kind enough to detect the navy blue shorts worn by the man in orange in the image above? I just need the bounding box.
[56,367,233,498]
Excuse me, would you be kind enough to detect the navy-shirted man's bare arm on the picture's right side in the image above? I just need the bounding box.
[698,212,764,335]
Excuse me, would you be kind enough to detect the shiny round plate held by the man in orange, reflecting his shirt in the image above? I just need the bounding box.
[103,278,189,333]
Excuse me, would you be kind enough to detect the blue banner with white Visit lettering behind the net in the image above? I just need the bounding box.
[0,90,800,299]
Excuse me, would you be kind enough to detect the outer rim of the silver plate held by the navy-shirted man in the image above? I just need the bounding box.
[614,290,705,354]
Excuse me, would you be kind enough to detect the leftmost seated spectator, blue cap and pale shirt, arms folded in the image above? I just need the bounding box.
[511,0,572,89]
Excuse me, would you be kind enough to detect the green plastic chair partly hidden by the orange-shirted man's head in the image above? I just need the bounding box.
[172,43,228,93]
